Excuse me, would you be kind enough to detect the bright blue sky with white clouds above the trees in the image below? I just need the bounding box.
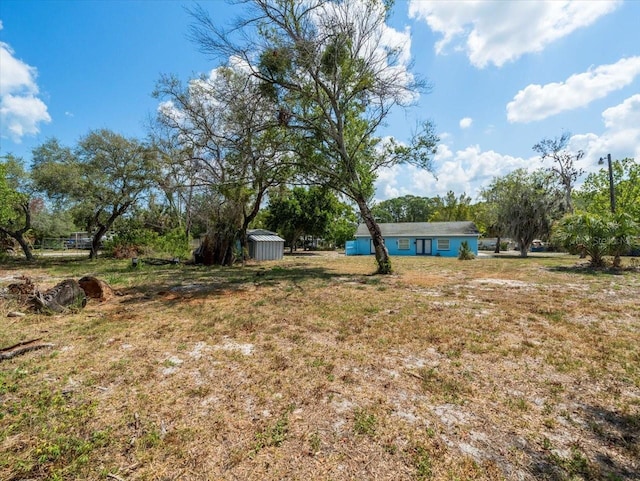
[0,0,640,201]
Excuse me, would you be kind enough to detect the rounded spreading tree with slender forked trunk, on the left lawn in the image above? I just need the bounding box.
[32,129,158,259]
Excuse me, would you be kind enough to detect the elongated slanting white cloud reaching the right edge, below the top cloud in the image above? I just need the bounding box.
[507,57,640,123]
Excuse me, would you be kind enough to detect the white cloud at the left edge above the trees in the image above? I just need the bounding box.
[0,40,51,143]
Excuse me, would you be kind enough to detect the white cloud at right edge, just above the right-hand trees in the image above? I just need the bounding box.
[569,94,640,166]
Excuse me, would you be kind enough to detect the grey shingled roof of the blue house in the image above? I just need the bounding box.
[356,221,479,237]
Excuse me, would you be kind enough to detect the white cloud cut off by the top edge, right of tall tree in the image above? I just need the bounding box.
[409,0,622,68]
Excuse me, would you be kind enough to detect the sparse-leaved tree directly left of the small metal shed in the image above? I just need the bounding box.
[155,59,290,265]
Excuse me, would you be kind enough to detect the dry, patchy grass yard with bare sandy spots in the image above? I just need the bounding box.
[0,254,640,481]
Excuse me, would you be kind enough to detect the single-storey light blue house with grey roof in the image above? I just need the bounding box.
[346,221,479,257]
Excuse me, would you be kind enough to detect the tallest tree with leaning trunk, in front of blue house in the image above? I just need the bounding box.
[192,0,437,273]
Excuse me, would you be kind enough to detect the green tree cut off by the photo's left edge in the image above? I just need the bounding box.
[0,155,33,261]
